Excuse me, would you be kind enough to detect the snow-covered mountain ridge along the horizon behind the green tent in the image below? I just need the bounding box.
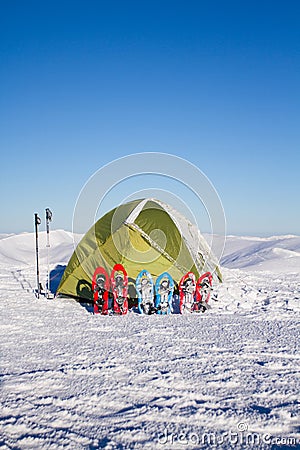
[0,230,300,273]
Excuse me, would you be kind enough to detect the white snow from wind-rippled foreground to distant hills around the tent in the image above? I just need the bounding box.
[0,230,300,450]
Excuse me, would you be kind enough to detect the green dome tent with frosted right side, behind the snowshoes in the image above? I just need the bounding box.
[57,199,221,300]
